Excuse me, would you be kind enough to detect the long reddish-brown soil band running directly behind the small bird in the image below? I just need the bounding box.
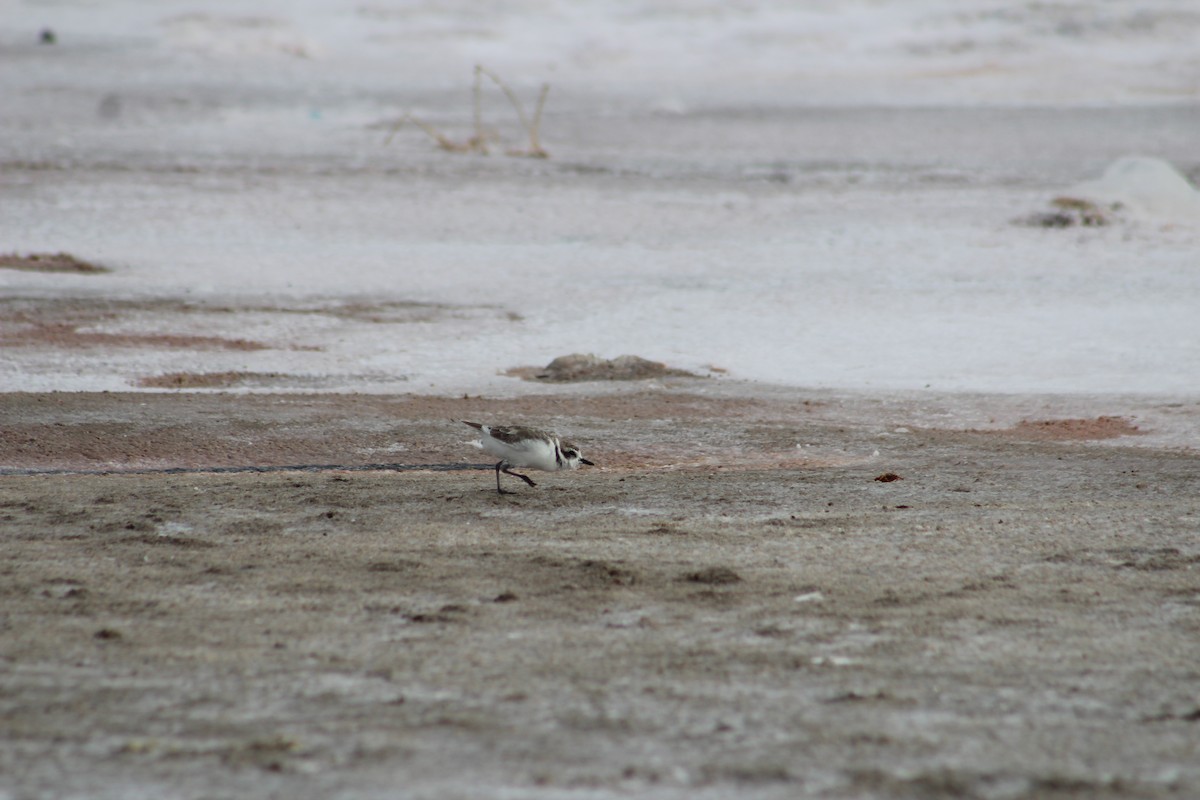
[0,391,852,474]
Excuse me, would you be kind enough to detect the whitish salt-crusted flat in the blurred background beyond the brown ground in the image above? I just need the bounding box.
[0,0,1200,393]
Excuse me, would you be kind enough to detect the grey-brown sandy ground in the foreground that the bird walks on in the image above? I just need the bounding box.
[0,380,1200,799]
